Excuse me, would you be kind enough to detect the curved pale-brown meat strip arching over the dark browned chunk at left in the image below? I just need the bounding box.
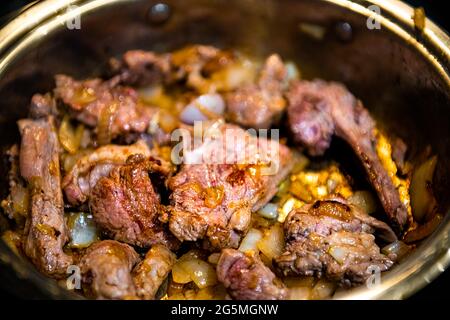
[62,140,151,205]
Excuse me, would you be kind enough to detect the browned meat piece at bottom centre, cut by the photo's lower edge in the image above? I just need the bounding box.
[217,249,288,300]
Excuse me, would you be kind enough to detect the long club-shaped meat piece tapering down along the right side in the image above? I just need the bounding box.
[288,80,408,230]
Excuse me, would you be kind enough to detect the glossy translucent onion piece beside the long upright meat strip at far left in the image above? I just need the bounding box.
[67,212,99,249]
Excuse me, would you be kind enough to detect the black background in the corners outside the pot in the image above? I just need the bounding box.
[0,0,450,300]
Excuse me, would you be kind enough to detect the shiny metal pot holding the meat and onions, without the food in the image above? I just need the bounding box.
[0,0,450,299]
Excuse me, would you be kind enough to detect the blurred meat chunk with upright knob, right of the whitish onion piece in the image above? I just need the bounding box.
[226,54,287,129]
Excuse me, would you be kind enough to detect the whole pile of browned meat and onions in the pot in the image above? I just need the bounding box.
[2,45,441,299]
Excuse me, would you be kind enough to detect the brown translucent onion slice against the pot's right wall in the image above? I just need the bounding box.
[410,156,437,222]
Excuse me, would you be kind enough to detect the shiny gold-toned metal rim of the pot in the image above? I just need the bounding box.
[0,0,450,299]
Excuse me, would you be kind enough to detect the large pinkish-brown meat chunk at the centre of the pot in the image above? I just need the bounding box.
[168,122,292,250]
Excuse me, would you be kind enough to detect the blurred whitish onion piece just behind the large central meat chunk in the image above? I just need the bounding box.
[180,93,225,124]
